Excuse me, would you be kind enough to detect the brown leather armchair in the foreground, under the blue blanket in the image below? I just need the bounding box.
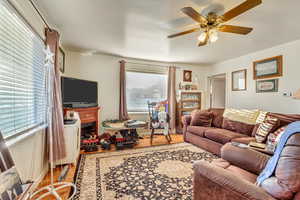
[193,133,300,200]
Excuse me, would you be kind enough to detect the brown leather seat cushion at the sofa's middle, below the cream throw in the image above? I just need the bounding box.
[204,128,245,144]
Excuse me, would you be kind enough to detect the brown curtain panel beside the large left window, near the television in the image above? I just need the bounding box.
[45,28,66,161]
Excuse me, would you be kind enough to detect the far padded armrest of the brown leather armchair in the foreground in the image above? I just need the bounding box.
[221,143,270,175]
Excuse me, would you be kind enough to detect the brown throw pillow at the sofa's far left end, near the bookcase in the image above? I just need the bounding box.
[191,110,213,127]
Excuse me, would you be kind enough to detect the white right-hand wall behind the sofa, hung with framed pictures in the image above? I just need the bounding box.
[210,40,300,113]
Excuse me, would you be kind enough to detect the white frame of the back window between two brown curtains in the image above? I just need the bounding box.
[125,68,168,115]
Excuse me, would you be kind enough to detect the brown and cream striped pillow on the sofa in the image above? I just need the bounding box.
[255,116,279,143]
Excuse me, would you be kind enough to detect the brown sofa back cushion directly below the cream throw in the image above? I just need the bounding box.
[222,118,255,136]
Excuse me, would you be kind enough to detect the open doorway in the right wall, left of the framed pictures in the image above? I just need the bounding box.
[208,74,226,108]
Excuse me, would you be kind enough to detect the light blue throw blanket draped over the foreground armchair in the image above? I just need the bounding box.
[256,121,300,185]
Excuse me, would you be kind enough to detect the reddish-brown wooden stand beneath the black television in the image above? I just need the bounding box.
[64,107,100,140]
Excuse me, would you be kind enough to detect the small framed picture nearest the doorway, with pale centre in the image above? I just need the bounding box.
[231,69,247,91]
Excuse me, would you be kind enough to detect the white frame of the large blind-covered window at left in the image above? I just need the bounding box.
[0,0,49,141]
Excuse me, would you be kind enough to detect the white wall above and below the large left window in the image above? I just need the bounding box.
[3,0,48,186]
